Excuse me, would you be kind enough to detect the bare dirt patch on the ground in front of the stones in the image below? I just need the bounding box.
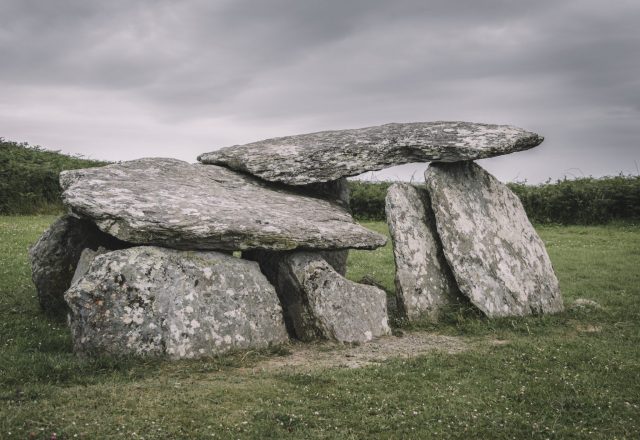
[242,332,469,371]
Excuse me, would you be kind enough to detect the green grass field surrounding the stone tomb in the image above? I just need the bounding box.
[0,217,640,439]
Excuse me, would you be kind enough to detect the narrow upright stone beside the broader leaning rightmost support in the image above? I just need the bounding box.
[385,183,460,321]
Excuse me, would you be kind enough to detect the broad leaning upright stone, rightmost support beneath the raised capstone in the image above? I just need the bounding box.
[425,162,563,317]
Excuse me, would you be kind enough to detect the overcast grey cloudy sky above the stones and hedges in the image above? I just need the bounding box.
[0,0,640,182]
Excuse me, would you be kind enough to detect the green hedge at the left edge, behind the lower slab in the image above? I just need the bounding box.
[0,138,106,215]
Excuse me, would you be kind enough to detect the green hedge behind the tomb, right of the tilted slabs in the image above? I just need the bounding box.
[349,176,640,225]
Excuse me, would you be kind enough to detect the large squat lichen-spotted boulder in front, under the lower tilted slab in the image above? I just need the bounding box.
[65,246,288,359]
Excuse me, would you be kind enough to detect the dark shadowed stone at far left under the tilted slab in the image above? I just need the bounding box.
[29,215,127,315]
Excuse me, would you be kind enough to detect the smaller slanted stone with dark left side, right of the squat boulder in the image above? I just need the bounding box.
[276,252,391,342]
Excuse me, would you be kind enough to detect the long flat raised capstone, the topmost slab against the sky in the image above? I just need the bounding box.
[198,121,543,185]
